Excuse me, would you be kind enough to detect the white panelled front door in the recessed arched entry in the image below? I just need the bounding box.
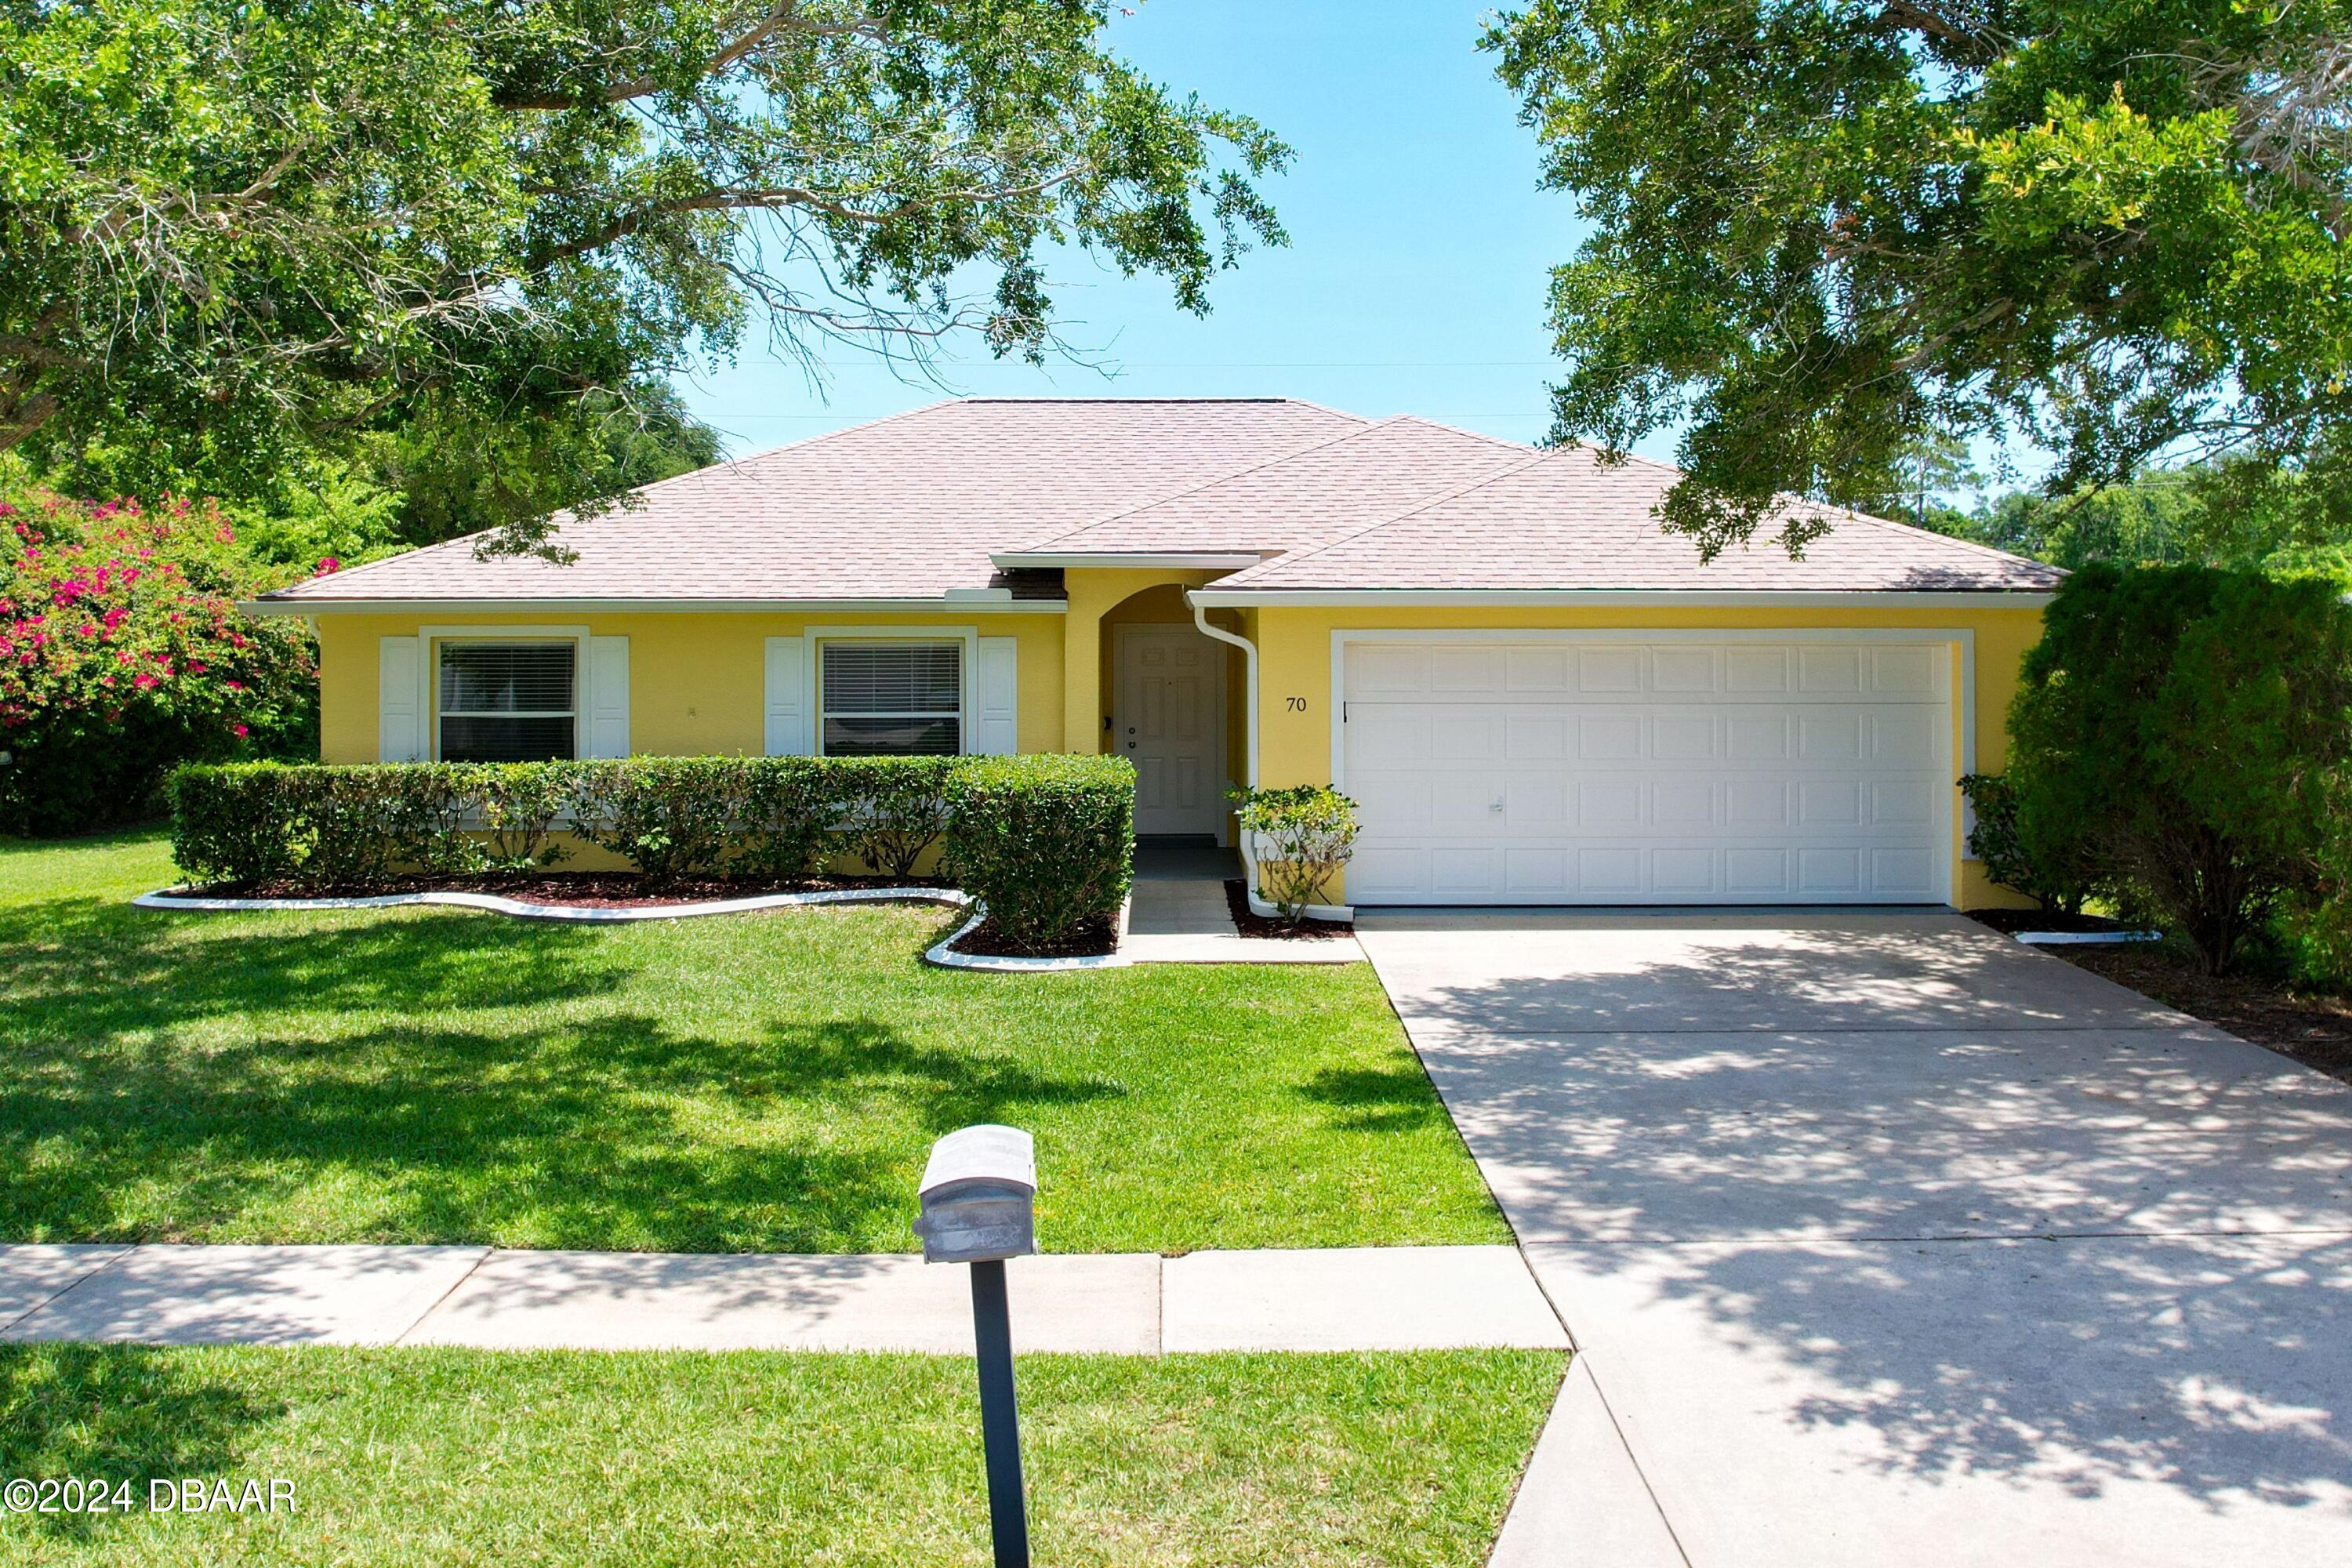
[1112,626,1225,832]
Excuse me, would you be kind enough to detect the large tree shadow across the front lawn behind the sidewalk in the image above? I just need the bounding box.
[0,1013,1124,1253]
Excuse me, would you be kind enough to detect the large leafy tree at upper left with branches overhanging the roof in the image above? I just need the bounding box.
[0,0,1287,548]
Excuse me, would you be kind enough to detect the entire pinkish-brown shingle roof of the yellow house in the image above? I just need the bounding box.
[266,397,2060,609]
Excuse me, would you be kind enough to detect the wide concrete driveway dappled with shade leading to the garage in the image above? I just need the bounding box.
[1359,912,2352,1568]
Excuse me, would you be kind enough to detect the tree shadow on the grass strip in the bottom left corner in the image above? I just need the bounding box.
[0,1345,287,1542]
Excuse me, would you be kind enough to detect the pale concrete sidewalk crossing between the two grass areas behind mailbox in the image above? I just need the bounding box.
[13,1246,1569,1356]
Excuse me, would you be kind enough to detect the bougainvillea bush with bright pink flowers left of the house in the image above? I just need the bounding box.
[0,499,318,834]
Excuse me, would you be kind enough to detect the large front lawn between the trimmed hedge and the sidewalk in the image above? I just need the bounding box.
[0,834,1510,1250]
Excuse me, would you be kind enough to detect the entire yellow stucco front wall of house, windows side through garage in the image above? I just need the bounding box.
[320,587,2042,907]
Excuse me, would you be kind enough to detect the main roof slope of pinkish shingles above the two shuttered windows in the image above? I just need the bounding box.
[266,397,1367,604]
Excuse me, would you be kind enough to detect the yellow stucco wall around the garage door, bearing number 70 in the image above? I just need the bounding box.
[1256,607,2042,909]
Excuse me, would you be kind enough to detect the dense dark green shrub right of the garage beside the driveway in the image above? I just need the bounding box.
[2006,567,2352,973]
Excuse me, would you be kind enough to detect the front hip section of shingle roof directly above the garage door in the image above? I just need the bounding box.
[1216,449,2065,593]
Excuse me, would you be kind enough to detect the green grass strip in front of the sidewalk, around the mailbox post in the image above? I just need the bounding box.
[0,1347,1564,1568]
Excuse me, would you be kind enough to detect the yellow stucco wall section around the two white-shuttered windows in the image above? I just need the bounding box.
[318,614,1063,762]
